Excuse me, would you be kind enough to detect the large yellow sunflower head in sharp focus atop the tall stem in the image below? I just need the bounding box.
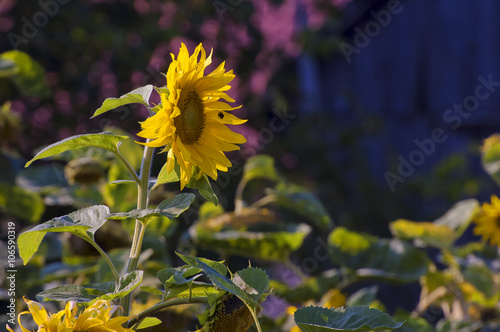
[137,44,246,189]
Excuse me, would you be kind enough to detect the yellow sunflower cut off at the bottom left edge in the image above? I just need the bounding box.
[7,298,133,332]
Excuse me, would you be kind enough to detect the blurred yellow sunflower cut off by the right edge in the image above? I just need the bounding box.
[474,195,500,246]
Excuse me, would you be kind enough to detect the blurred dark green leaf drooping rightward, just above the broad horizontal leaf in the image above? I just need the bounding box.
[273,183,333,231]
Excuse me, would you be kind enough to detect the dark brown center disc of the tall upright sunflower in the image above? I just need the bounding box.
[174,91,205,144]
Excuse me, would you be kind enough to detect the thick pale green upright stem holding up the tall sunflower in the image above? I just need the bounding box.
[121,145,154,316]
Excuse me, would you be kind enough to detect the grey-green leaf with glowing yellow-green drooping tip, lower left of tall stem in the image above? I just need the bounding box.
[17,205,109,265]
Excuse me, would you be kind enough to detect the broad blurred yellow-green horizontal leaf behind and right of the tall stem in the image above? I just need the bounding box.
[192,224,311,262]
